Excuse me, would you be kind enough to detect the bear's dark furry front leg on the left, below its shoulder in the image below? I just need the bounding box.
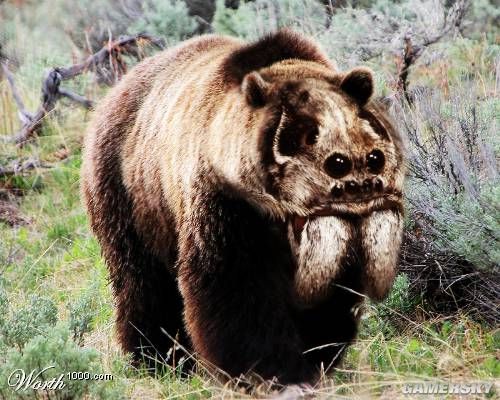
[178,193,315,384]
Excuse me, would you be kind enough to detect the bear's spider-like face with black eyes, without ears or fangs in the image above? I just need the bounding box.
[271,82,401,217]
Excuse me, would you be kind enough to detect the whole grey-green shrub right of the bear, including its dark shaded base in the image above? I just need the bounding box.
[397,78,500,322]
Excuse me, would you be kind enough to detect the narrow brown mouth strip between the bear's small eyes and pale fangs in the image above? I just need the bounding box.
[289,192,403,244]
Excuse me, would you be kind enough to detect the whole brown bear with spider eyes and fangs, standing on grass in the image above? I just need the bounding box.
[82,30,404,383]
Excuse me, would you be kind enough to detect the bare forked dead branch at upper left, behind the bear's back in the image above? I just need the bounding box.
[0,33,163,146]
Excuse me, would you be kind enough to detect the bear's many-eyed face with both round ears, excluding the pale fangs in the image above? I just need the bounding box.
[244,68,404,225]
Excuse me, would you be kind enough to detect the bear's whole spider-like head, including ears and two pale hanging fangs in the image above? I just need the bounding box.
[241,60,404,306]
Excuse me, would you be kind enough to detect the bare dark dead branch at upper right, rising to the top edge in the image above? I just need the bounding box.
[398,0,469,104]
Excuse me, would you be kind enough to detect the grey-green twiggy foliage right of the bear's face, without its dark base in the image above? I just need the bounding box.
[400,89,500,270]
